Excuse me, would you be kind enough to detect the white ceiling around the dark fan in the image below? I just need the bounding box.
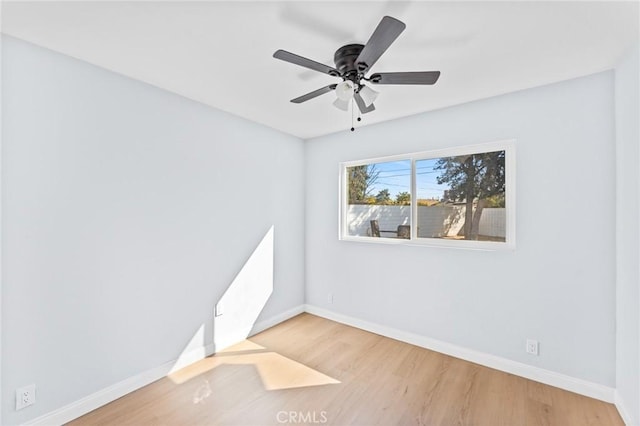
[2,1,639,139]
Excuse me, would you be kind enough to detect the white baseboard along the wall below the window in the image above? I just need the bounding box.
[305,305,616,403]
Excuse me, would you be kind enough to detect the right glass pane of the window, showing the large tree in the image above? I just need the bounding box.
[416,151,506,242]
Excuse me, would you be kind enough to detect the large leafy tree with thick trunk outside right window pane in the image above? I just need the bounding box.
[434,151,505,240]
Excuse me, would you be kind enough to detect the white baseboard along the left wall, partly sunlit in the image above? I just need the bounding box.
[24,305,304,426]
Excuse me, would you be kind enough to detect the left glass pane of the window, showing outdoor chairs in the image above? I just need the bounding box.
[346,160,411,238]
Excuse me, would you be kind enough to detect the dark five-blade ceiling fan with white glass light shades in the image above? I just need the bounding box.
[273,16,440,117]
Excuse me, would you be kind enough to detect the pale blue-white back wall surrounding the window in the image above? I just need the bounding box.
[305,72,616,387]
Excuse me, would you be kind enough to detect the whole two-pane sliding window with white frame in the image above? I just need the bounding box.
[340,141,515,249]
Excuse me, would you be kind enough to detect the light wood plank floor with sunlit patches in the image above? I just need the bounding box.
[71,314,623,426]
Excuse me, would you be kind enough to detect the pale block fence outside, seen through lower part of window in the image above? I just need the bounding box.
[347,204,506,238]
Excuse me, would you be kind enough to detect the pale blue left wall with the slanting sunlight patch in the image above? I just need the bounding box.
[1,37,304,425]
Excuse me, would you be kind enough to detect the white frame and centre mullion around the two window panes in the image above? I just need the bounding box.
[338,139,516,250]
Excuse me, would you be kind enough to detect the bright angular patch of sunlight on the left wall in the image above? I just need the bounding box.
[170,226,274,374]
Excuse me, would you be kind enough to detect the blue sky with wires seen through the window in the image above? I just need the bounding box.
[371,158,448,199]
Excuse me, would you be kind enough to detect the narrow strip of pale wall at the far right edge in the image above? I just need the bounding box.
[615,47,640,425]
